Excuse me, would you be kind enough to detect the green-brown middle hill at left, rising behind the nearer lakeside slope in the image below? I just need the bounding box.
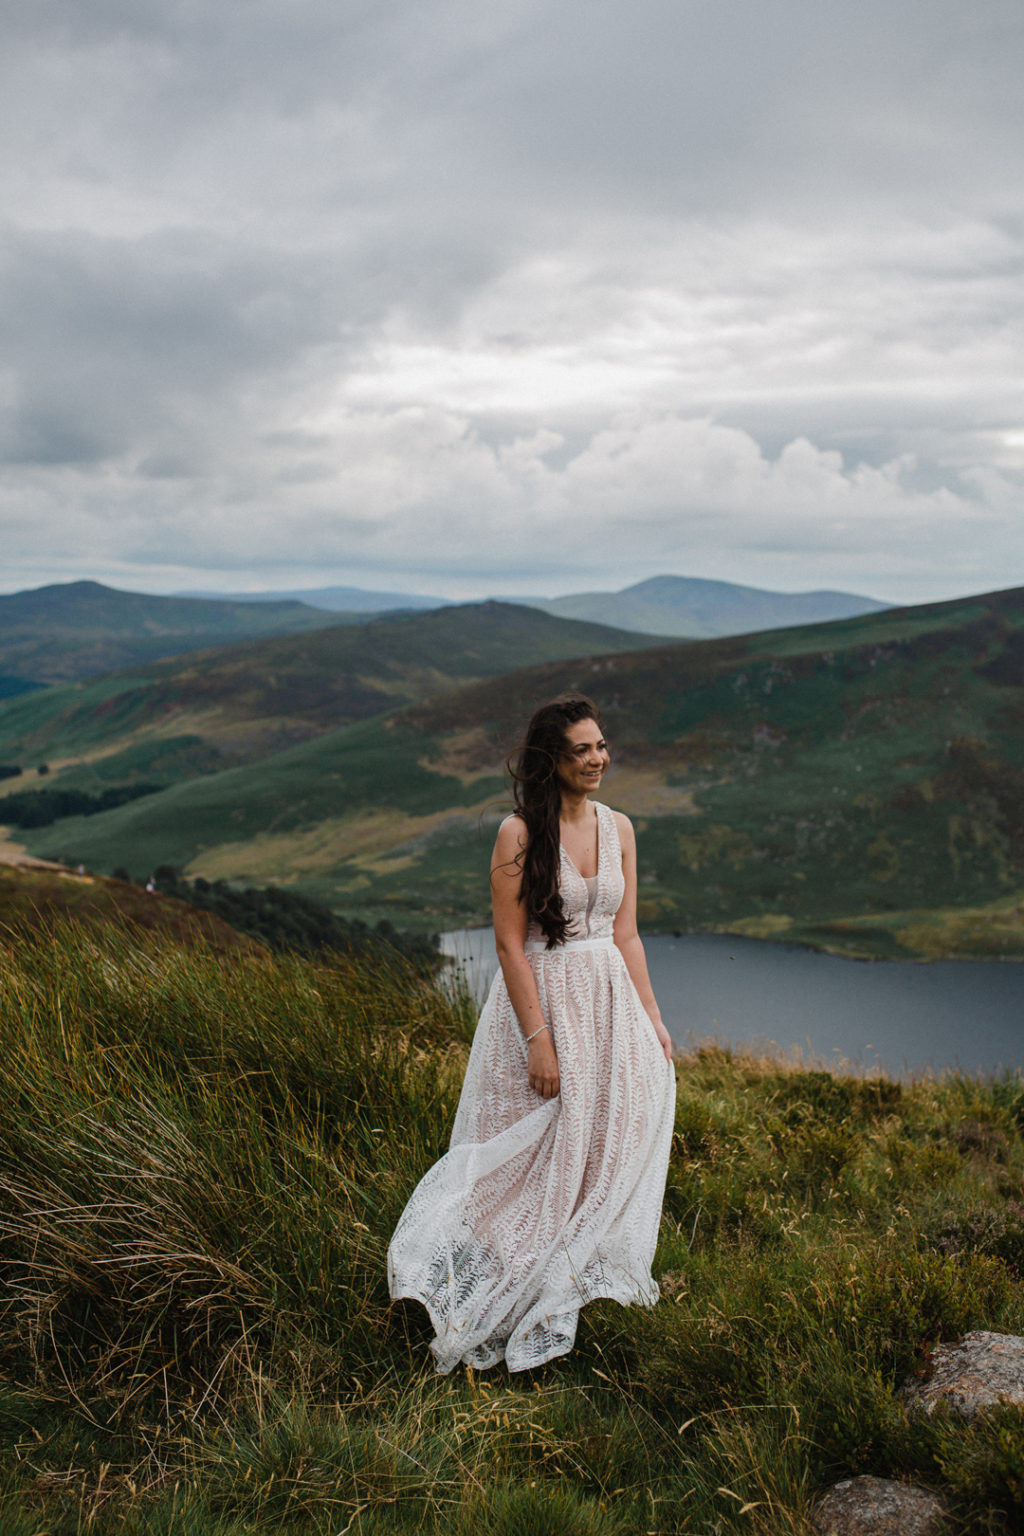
[0,602,651,805]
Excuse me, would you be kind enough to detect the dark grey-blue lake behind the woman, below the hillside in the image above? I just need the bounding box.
[442,928,1024,1077]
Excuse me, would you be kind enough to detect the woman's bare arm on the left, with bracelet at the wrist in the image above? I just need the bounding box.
[491,816,559,1098]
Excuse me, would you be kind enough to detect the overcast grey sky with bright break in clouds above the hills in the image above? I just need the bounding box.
[0,0,1024,602]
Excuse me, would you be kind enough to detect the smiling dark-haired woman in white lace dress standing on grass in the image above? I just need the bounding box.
[388,694,676,1372]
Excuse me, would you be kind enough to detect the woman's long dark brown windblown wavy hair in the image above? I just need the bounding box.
[508,693,600,949]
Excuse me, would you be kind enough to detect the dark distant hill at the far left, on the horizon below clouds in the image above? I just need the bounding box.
[0,581,336,681]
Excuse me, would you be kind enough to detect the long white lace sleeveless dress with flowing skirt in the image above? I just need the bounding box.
[388,805,676,1372]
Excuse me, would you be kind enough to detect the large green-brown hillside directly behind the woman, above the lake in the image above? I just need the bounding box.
[18,590,1024,955]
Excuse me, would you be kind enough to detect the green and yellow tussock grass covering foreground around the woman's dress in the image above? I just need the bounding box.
[0,925,1024,1536]
